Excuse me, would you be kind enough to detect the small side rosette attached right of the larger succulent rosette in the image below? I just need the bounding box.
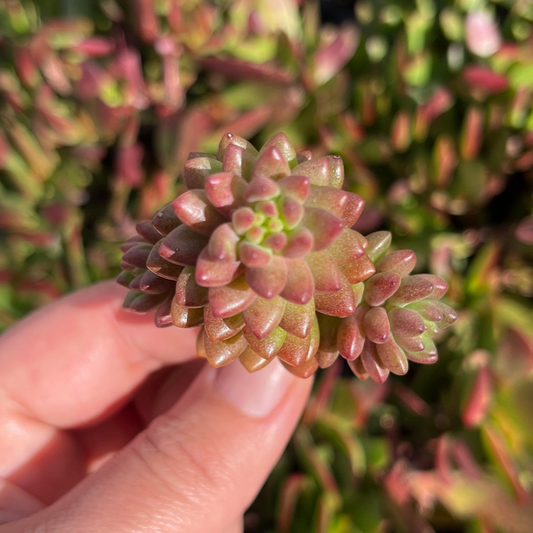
[317,231,457,383]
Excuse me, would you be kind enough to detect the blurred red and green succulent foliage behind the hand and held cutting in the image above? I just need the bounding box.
[0,0,533,533]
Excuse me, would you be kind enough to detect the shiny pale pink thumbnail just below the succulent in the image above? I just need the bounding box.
[215,359,294,418]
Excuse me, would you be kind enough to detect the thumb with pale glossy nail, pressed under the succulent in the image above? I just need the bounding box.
[19,359,311,533]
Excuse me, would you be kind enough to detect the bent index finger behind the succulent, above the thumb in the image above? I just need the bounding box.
[0,282,196,428]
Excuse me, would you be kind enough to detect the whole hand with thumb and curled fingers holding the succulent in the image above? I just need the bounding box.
[0,282,312,533]
